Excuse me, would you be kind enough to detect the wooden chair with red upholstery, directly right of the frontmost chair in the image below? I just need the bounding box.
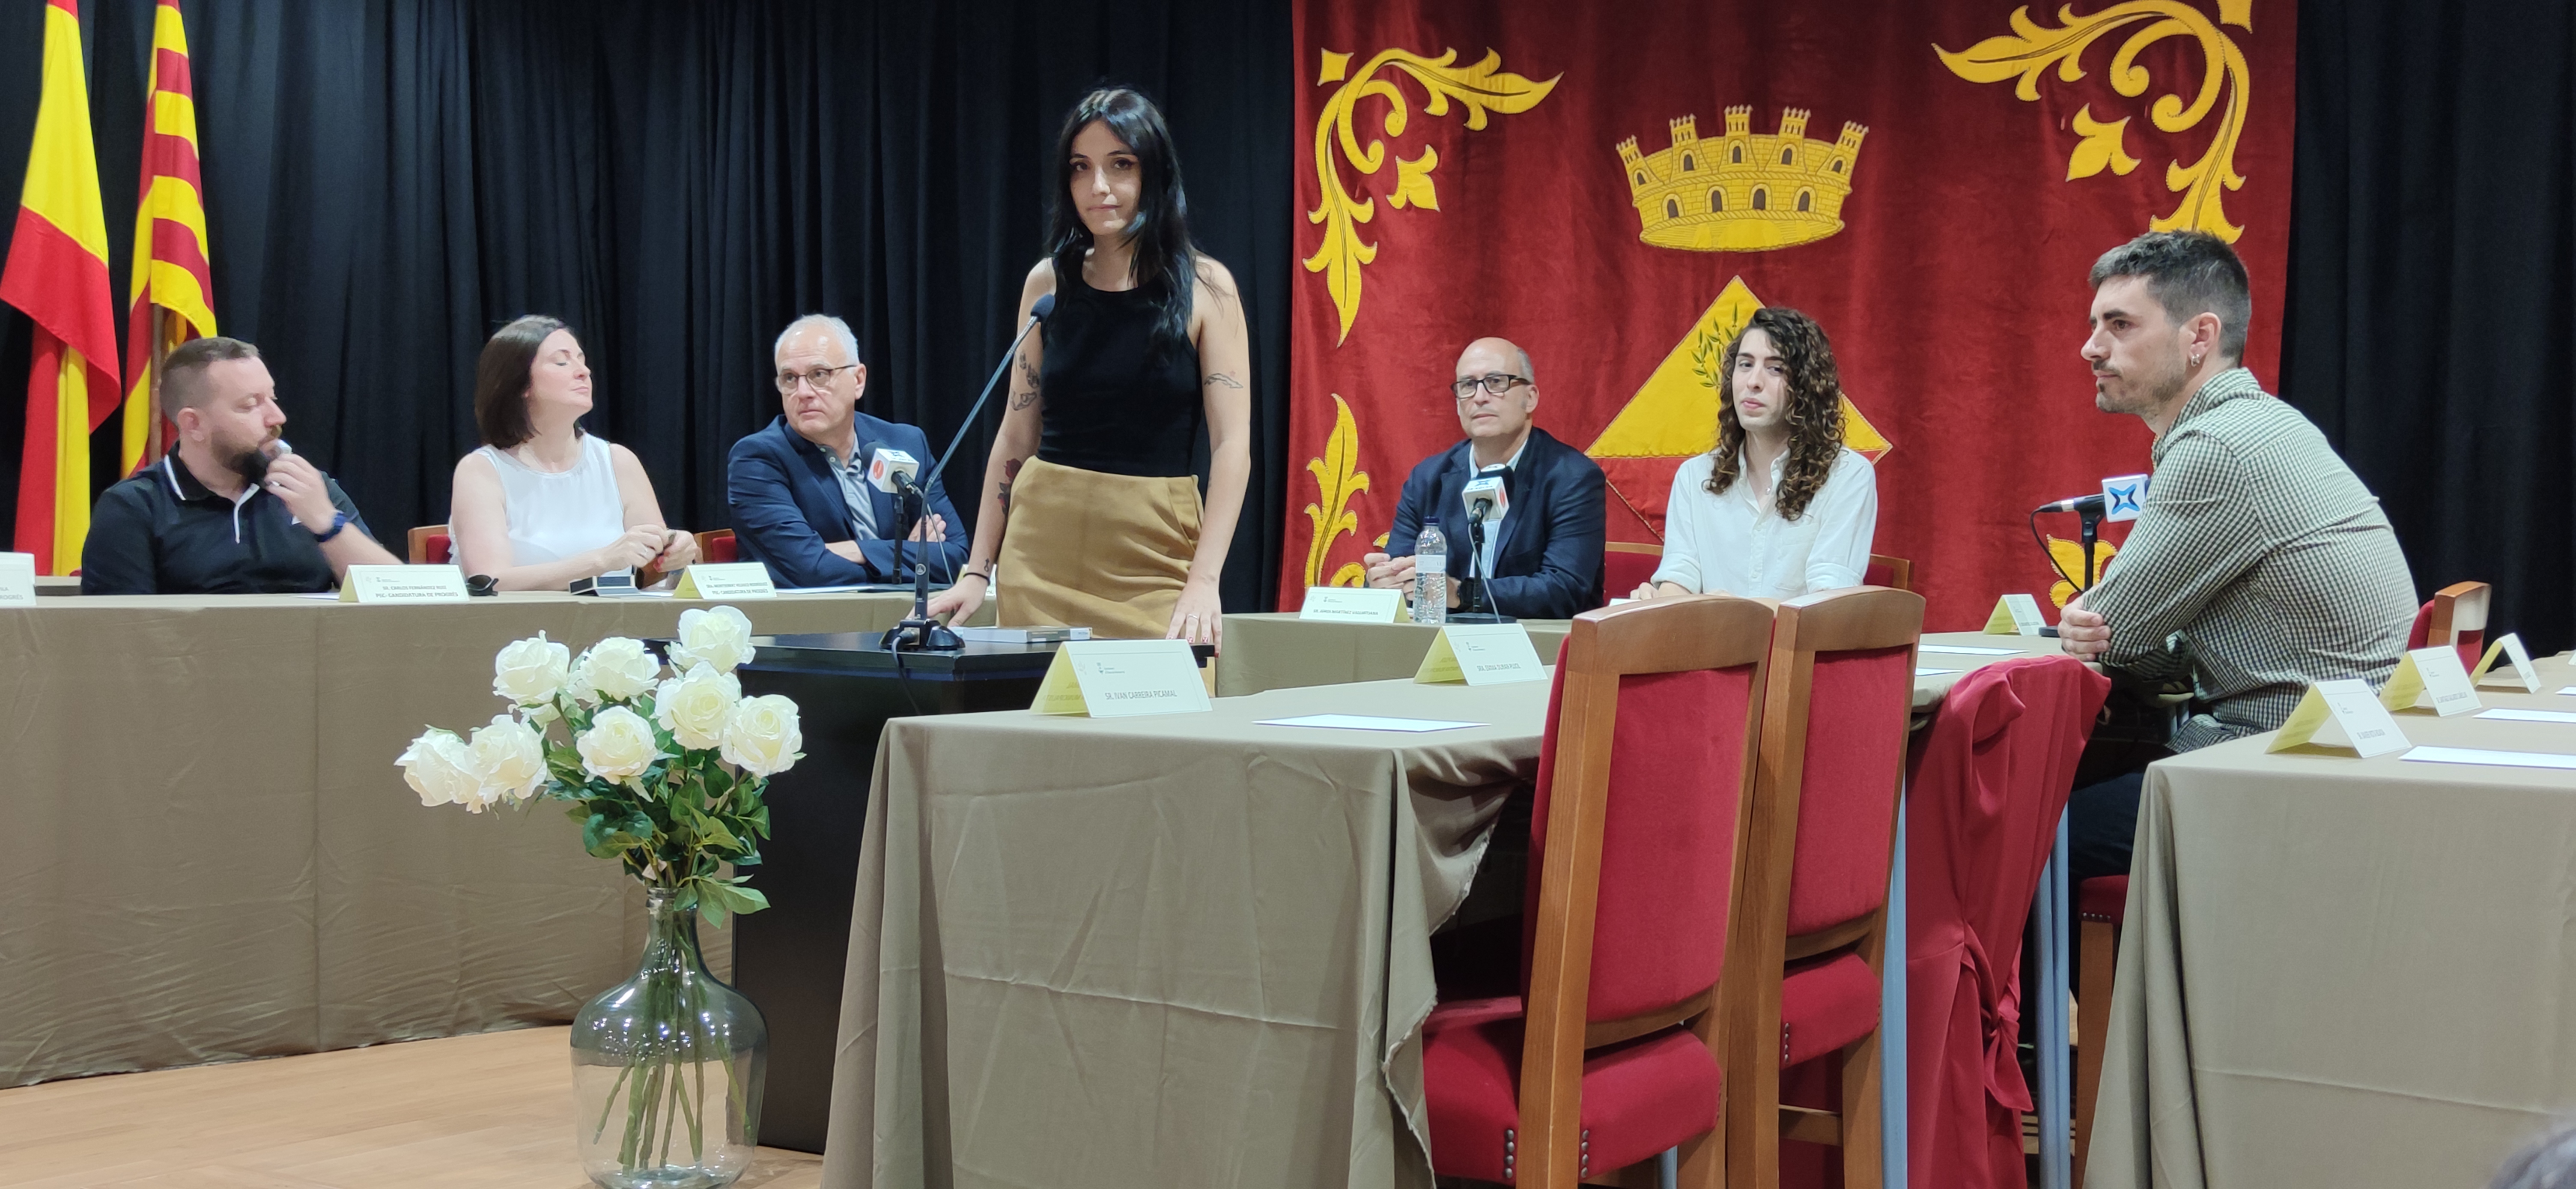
[1726,586,1924,1189]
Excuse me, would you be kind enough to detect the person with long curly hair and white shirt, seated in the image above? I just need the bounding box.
[1636,307,1878,598]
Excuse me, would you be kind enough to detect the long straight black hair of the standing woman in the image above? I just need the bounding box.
[1046,88,1198,343]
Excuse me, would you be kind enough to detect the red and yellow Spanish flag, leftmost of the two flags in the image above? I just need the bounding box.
[0,0,121,575]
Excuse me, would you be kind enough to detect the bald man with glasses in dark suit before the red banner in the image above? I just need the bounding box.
[1363,338,1607,619]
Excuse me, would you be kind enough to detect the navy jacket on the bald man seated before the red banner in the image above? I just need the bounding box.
[1386,426,1610,619]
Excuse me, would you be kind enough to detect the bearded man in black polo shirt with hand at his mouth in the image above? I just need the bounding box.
[80,338,399,596]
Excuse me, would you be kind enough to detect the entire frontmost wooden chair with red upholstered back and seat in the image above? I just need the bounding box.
[1422,598,1772,1189]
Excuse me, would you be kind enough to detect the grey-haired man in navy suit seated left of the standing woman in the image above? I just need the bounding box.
[727,315,966,588]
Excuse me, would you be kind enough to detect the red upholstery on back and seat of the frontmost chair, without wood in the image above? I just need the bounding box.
[1422,621,1757,1181]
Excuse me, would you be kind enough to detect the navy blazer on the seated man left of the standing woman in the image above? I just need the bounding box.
[724,412,969,588]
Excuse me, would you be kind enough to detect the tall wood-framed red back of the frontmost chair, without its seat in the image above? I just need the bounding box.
[1517,596,1772,1184]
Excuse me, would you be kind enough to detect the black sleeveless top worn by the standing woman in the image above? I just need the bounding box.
[1038,268,1205,477]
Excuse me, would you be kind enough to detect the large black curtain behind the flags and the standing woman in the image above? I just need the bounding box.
[0,0,1293,609]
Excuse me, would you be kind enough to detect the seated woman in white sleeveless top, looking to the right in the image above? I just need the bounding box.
[448,315,698,591]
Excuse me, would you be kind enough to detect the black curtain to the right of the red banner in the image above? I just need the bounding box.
[2282,0,2576,652]
